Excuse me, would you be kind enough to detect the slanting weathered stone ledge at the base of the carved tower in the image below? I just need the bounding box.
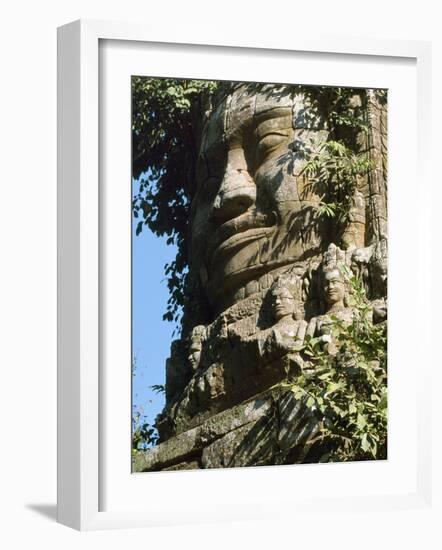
[133,387,323,472]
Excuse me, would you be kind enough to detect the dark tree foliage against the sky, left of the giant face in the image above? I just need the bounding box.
[132,77,217,328]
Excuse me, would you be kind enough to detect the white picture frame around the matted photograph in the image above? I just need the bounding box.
[58,21,432,530]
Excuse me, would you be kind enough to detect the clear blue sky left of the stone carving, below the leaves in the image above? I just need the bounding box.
[132,181,176,434]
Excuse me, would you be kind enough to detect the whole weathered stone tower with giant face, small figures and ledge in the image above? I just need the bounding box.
[134,84,387,471]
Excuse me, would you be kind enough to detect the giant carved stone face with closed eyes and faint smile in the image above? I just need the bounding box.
[191,85,327,313]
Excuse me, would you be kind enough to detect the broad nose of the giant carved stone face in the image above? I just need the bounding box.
[213,165,256,223]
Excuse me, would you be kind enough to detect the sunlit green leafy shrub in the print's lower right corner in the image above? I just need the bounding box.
[284,271,387,462]
